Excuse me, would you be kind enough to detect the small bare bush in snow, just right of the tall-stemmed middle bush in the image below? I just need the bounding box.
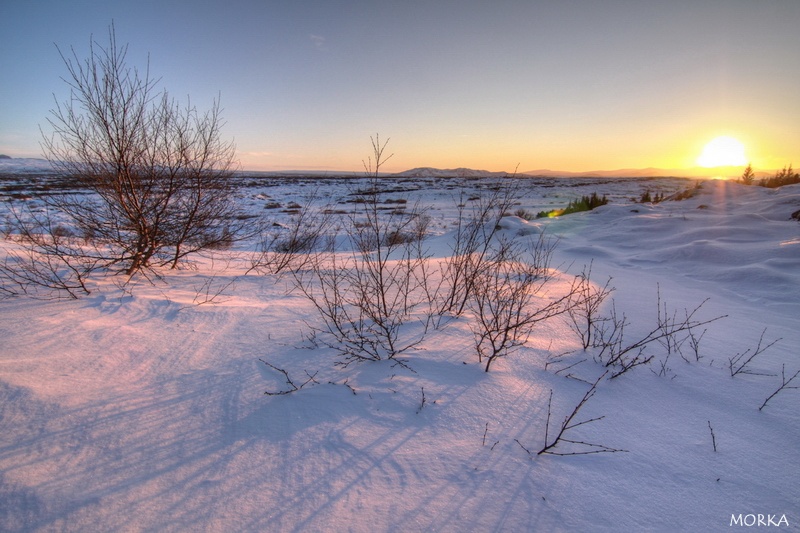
[467,235,571,372]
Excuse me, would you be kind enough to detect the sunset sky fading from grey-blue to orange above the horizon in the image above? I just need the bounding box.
[0,0,800,171]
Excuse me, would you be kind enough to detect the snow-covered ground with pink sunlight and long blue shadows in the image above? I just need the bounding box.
[0,172,800,532]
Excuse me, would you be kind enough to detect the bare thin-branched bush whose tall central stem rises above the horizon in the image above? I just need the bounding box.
[292,136,432,365]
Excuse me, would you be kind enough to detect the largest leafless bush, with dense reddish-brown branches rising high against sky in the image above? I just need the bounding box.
[6,26,253,296]
